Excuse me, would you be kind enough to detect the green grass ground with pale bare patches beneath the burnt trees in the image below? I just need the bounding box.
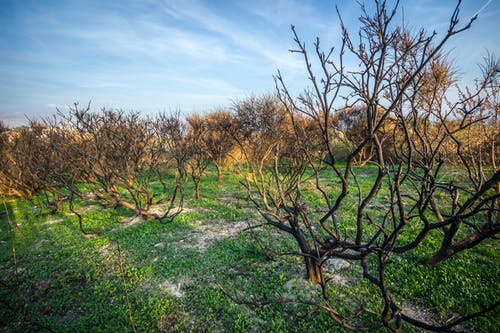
[0,167,500,332]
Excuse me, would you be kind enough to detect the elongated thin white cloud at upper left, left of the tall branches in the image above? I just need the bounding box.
[33,10,240,66]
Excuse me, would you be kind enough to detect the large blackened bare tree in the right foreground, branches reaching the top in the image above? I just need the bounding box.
[240,1,500,332]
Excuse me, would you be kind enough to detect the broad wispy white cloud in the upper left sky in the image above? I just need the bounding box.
[23,4,242,64]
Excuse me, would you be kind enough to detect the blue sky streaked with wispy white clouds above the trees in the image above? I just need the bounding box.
[0,0,500,127]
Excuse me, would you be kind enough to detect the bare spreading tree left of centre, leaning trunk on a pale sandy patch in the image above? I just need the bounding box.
[54,104,182,225]
